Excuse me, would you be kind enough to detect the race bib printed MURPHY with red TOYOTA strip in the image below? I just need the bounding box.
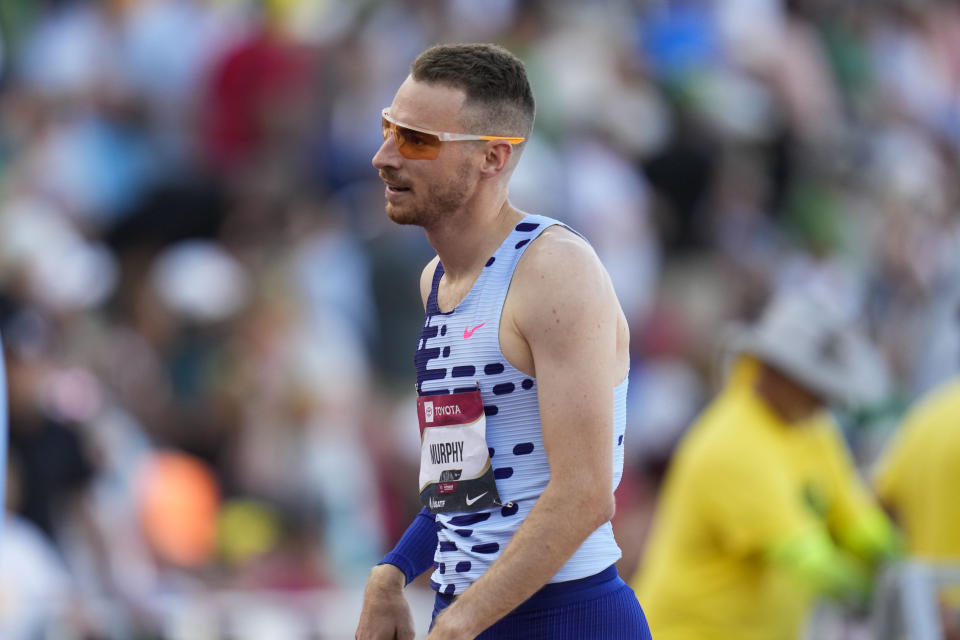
[417,391,500,513]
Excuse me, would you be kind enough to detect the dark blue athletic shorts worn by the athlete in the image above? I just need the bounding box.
[433,565,651,640]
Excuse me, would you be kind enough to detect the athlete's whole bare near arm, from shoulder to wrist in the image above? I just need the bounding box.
[430,231,626,640]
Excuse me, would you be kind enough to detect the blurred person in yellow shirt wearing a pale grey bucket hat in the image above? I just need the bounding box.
[633,295,895,640]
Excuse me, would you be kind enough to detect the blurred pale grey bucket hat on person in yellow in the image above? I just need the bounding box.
[725,293,888,406]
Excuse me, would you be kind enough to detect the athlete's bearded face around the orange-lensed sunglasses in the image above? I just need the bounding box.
[373,76,478,228]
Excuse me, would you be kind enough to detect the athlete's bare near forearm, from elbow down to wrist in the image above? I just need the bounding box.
[438,481,613,638]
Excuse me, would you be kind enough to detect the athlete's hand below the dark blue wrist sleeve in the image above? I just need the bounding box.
[354,564,415,640]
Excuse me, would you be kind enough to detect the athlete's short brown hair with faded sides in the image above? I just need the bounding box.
[411,44,536,138]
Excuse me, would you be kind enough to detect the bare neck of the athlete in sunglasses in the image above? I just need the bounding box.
[425,198,523,281]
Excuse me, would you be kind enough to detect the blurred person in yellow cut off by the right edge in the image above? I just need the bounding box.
[873,378,960,639]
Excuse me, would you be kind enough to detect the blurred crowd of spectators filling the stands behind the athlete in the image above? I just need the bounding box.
[0,0,960,638]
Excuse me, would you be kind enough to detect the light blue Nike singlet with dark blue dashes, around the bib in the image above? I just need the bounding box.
[414,215,627,595]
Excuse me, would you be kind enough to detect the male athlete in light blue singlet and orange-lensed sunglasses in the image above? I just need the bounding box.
[356,44,650,640]
